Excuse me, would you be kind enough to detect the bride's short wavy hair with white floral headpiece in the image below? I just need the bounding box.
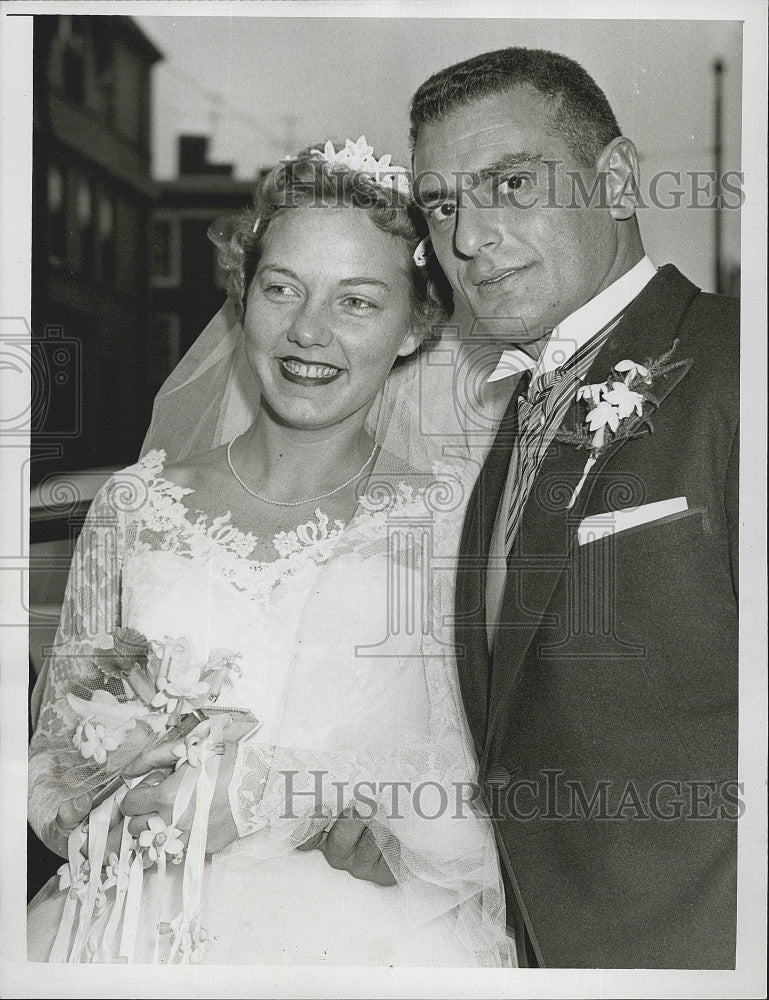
[208,144,453,336]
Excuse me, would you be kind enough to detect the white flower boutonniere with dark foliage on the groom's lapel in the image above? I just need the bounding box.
[555,340,689,509]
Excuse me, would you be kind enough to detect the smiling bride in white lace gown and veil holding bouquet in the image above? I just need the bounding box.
[28,139,512,966]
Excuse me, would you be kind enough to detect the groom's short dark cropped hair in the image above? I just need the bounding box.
[411,48,622,166]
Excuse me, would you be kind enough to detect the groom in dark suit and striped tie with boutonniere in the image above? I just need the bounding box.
[323,49,742,968]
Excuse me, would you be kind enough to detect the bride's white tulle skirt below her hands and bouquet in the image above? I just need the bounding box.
[27,851,496,967]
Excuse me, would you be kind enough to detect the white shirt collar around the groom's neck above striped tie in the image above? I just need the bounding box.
[488,256,657,382]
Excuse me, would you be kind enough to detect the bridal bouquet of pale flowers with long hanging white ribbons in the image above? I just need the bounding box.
[49,628,255,963]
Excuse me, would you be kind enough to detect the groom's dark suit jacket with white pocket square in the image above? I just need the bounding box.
[456,265,741,968]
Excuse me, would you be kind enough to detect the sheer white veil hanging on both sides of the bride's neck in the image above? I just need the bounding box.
[141,299,510,473]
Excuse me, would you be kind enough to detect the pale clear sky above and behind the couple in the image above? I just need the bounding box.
[136,14,741,289]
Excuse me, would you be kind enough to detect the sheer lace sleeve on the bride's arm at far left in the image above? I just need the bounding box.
[28,477,130,857]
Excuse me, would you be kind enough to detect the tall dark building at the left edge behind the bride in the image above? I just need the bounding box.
[31,15,162,483]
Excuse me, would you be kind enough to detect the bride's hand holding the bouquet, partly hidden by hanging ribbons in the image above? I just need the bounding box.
[120,723,253,854]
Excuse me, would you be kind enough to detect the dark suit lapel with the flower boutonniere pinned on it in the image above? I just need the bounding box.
[486,264,699,749]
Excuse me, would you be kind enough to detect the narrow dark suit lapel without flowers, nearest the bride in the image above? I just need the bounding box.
[455,372,523,753]
